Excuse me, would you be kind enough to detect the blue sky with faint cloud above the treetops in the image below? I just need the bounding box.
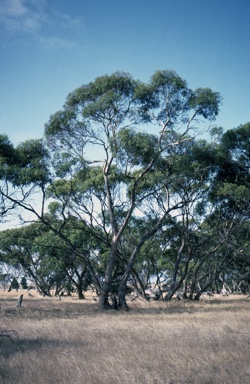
[0,0,250,144]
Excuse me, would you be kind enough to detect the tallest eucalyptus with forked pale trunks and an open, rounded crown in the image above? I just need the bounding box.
[0,71,220,309]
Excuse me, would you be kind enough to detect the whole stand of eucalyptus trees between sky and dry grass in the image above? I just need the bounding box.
[0,70,250,310]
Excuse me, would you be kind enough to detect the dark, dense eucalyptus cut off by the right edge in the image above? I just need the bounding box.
[176,124,250,298]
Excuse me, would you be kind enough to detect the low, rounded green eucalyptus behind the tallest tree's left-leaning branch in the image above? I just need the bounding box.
[0,214,96,299]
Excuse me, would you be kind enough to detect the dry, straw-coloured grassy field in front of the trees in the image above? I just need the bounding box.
[0,292,250,384]
